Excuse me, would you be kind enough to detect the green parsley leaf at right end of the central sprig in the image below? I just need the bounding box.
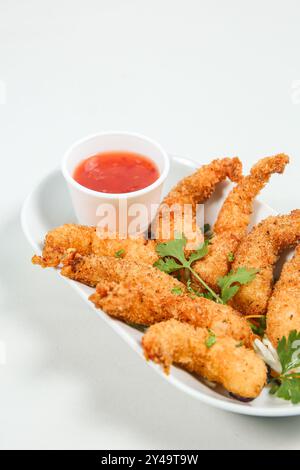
[218,267,258,304]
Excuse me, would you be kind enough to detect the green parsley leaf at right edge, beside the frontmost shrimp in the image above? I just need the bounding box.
[270,330,300,405]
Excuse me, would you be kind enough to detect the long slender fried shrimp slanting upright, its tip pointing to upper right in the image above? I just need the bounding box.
[194,154,289,290]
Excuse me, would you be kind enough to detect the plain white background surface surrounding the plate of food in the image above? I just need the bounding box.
[0,0,300,449]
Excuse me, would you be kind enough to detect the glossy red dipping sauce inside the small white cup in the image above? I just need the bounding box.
[73,151,159,194]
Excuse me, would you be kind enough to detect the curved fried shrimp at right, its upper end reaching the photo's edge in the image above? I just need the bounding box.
[232,210,300,315]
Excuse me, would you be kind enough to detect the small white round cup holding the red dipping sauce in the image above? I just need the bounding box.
[62,132,170,235]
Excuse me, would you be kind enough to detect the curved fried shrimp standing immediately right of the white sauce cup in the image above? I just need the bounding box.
[154,157,242,248]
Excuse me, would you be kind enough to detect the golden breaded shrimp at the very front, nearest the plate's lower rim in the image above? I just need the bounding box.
[142,320,267,398]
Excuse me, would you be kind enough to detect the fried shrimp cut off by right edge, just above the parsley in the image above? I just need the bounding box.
[267,245,300,347]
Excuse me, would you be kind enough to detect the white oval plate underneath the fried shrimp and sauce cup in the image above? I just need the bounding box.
[21,157,300,417]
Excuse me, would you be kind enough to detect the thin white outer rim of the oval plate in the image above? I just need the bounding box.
[20,154,300,418]
